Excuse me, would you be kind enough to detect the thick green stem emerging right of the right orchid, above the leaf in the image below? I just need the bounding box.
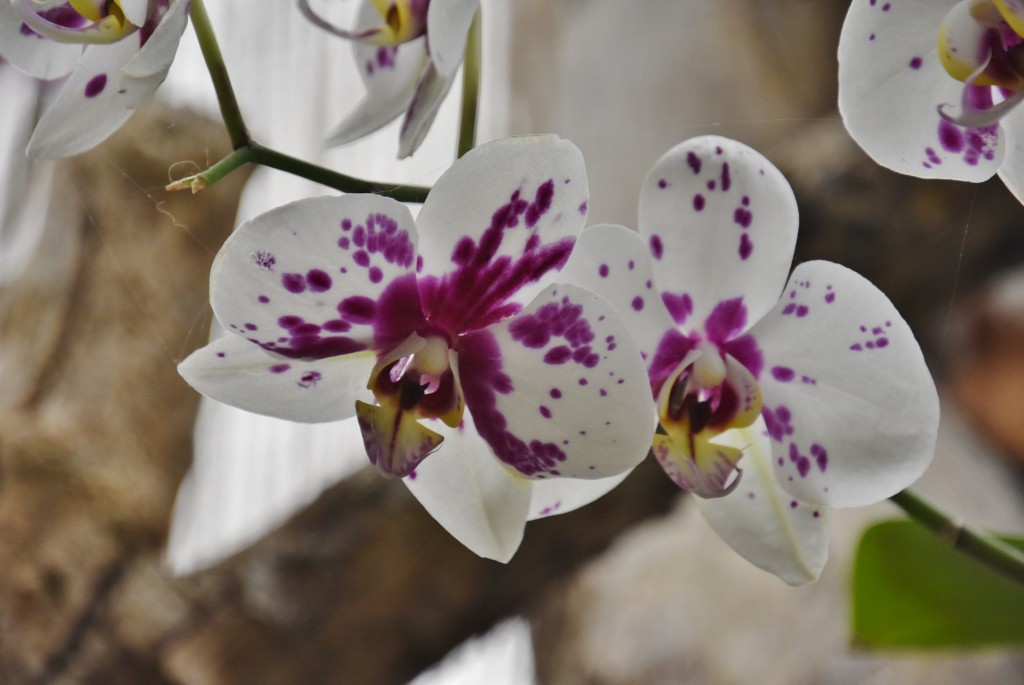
[889,489,1024,583]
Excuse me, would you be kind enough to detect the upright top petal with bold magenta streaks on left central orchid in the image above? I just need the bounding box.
[417,136,588,334]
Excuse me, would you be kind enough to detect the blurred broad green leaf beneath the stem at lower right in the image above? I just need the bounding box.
[852,520,1024,648]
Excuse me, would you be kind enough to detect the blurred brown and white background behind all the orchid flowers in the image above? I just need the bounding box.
[0,0,1024,685]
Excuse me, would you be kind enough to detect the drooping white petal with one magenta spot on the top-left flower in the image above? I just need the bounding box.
[27,39,138,159]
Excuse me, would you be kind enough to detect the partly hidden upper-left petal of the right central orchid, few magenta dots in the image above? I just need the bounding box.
[558,224,675,366]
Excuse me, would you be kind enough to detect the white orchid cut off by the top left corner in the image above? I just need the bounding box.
[0,0,189,158]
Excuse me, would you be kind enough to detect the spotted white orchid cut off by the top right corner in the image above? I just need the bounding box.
[839,0,1024,199]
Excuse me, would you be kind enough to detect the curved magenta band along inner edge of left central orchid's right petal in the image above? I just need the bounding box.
[459,331,565,476]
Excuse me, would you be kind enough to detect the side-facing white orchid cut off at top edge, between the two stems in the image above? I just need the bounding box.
[298,0,479,159]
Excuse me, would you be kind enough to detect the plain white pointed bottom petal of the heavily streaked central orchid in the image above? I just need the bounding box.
[402,413,530,562]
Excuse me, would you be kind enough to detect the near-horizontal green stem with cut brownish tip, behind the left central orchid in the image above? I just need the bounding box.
[167,142,430,203]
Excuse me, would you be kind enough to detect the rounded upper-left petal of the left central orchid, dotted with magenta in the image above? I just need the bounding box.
[210,195,422,358]
